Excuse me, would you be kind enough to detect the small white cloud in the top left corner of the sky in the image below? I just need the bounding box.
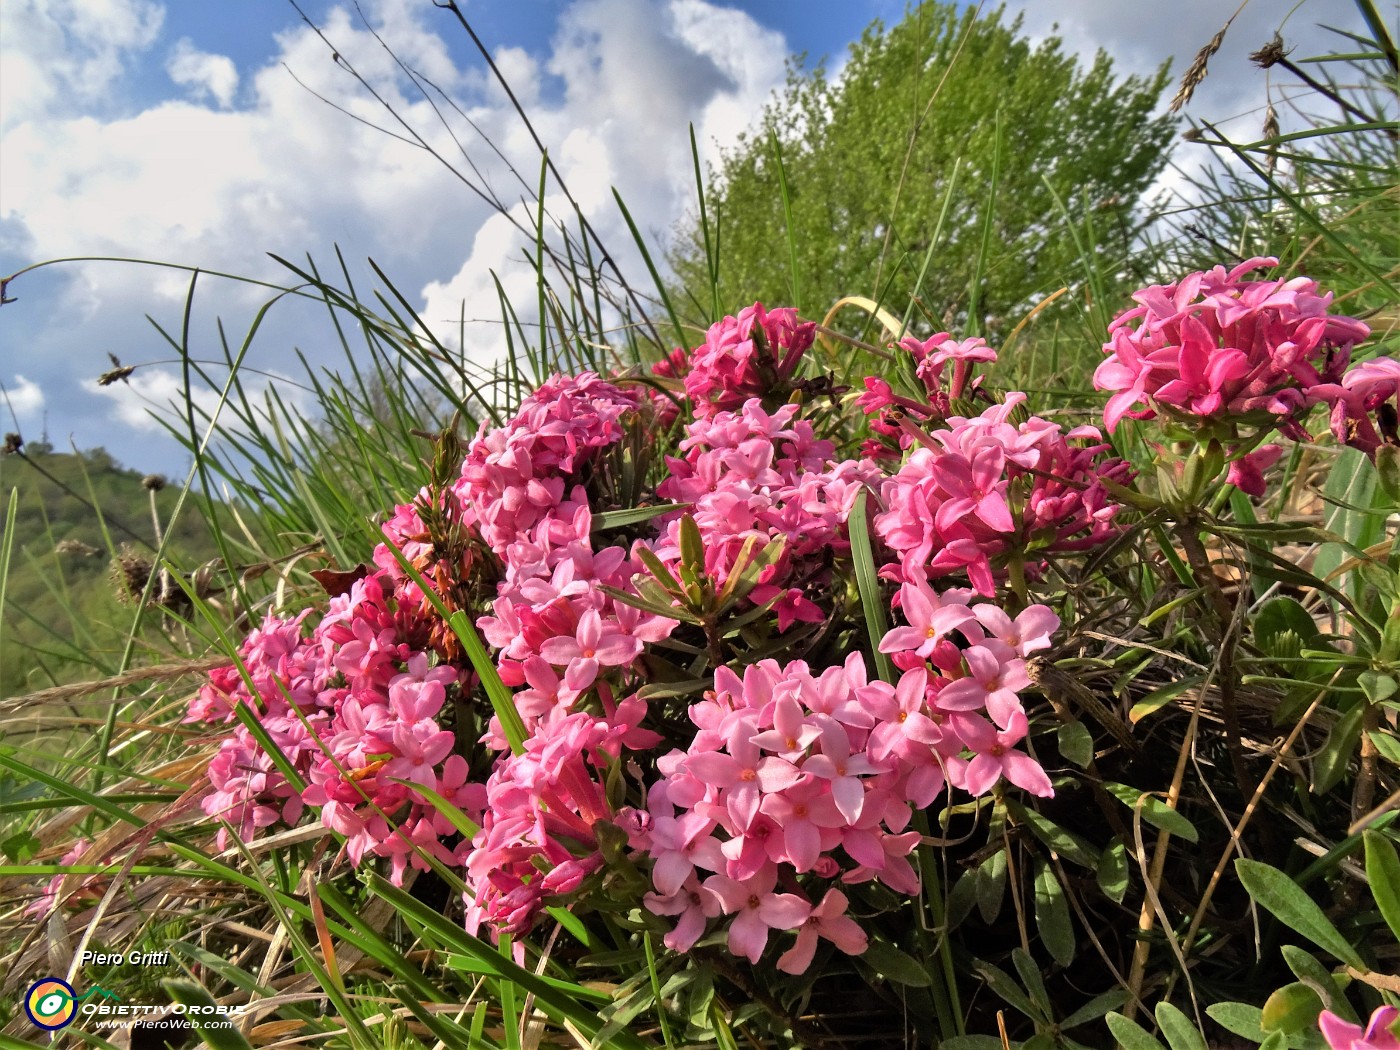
[0,0,165,129]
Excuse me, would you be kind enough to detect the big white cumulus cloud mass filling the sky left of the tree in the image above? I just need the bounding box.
[0,0,787,467]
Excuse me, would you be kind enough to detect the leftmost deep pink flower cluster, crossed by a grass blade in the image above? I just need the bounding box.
[186,573,486,882]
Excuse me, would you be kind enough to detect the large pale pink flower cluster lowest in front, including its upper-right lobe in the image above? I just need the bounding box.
[631,584,1058,973]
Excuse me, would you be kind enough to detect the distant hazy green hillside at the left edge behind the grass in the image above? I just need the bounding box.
[0,444,214,696]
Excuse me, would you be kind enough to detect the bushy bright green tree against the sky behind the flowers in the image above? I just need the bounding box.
[671,3,1175,336]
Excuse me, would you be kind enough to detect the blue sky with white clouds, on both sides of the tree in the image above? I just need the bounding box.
[0,0,1357,473]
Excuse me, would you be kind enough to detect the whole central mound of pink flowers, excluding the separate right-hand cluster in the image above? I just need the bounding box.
[175,296,1126,973]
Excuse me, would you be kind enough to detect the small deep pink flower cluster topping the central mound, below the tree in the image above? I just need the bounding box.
[680,302,816,419]
